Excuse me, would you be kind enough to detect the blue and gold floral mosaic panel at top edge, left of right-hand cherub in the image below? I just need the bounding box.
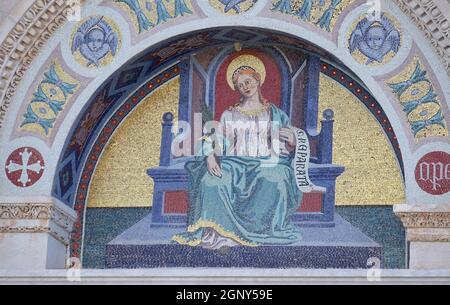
[272,0,354,32]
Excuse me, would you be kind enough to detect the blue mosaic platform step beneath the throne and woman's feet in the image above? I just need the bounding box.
[106,215,382,268]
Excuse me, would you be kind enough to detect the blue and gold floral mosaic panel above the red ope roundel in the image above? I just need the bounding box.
[388,58,448,139]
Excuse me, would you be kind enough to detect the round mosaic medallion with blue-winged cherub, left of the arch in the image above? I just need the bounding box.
[71,16,120,68]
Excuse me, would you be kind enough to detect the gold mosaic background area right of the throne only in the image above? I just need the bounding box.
[319,75,405,205]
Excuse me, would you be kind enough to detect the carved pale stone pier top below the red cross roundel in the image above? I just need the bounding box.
[0,197,76,270]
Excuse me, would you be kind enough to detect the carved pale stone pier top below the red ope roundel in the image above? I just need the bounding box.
[394,203,450,269]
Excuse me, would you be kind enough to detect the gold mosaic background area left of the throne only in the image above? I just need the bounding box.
[88,77,180,208]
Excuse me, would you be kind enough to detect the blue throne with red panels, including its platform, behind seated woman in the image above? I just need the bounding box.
[107,48,381,268]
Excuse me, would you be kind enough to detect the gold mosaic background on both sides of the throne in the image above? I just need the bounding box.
[88,76,405,207]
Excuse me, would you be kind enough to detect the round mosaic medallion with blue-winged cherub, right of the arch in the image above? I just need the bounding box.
[348,13,401,65]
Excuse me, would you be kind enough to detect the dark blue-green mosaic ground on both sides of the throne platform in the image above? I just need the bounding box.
[83,206,406,269]
